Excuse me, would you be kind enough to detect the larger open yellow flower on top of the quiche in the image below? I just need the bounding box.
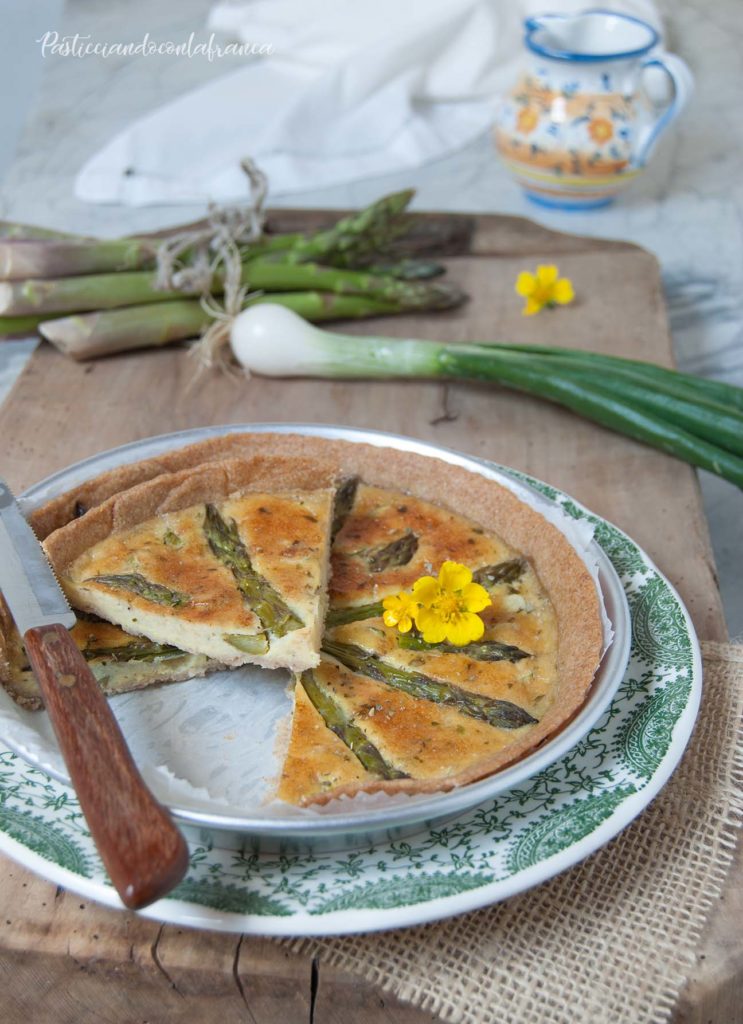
[412,562,492,647]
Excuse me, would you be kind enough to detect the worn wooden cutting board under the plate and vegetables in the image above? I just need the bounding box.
[0,212,743,1024]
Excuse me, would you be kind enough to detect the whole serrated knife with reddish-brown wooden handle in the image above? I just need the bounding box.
[0,479,188,910]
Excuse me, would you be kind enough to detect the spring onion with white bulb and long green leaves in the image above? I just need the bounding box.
[230,303,743,487]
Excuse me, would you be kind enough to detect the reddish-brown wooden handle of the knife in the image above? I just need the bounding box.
[24,626,188,910]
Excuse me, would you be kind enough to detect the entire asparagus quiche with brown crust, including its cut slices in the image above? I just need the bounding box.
[0,435,602,805]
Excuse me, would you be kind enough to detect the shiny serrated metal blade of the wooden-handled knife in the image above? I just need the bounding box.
[0,479,75,636]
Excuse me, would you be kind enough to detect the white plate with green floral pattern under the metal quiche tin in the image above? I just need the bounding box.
[0,428,701,935]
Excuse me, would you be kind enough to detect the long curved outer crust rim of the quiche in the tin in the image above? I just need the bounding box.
[32,433,603,803]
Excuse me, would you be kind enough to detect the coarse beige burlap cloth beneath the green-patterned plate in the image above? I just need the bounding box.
[293,643,743,1024]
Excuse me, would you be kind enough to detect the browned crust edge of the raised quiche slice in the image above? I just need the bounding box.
[44,456,333,573]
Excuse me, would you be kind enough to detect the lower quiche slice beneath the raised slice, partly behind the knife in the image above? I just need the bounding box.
[0,596,224,711]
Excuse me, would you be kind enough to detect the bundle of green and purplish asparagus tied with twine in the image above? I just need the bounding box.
[0,189,466,359]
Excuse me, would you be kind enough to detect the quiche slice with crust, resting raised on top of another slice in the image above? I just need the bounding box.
[39,458,334,671]
